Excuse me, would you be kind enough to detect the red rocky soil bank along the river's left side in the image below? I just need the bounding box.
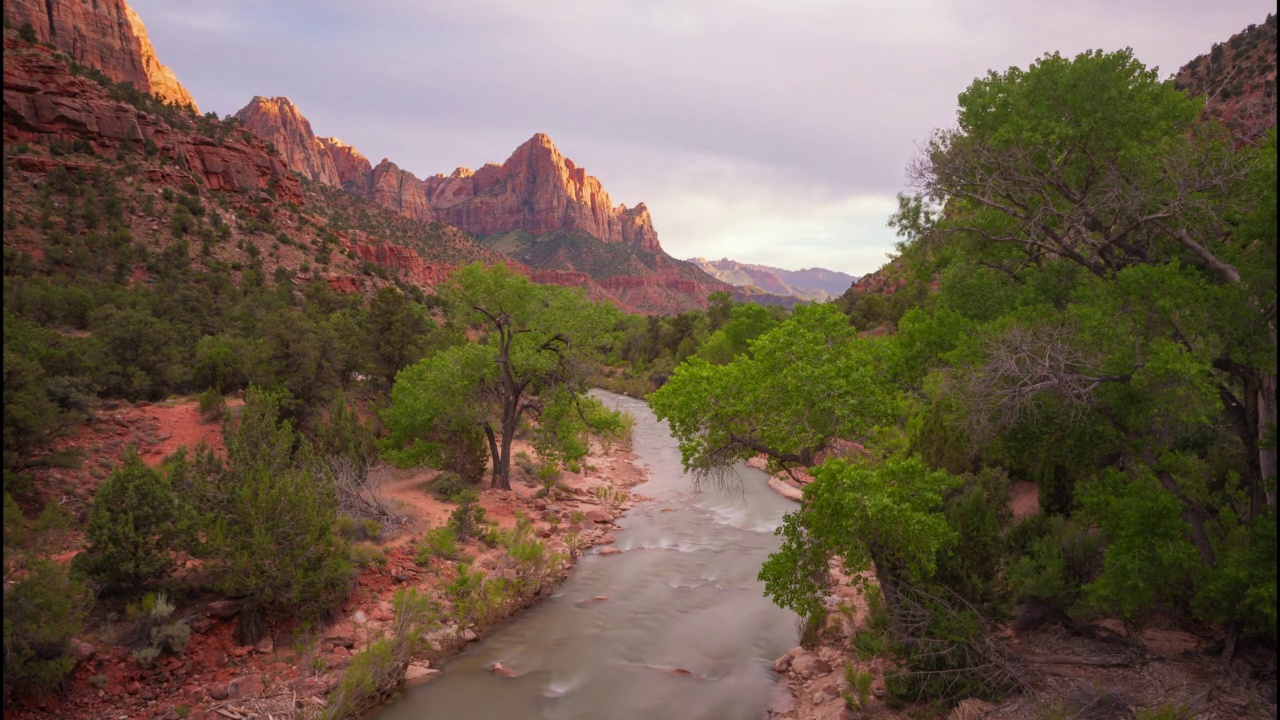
[5,415,646,720]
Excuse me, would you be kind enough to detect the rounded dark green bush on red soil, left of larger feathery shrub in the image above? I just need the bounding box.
[73,450,179,589]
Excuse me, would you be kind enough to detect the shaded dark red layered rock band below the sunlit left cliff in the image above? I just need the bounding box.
[4,38,301,200]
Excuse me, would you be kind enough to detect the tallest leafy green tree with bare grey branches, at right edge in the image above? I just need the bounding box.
[911,50,1276,645]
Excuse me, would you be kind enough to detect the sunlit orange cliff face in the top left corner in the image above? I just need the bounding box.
[4,0,196,108]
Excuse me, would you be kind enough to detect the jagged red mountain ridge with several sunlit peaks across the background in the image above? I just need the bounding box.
[236,96,732,313]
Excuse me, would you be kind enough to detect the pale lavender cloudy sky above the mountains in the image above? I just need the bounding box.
[131,0,1275,274]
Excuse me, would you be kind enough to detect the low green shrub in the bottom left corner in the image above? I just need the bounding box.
[4,560,88,694]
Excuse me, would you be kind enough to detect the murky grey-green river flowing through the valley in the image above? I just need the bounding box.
[378,391,797,720]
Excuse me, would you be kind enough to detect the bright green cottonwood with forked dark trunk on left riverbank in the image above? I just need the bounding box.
[384,264,618,489]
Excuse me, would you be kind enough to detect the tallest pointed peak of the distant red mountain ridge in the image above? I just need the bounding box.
[424,133,662,252]
